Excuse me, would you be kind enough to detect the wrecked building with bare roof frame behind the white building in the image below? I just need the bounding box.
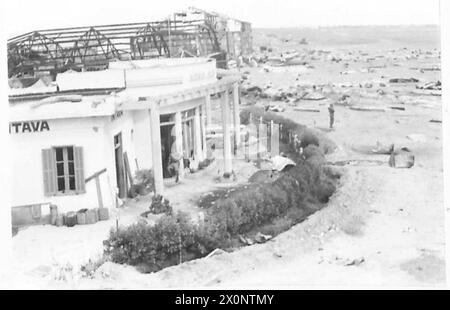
[8,8,252,78]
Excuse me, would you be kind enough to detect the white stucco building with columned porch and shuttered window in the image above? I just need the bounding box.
[9,58,240,225]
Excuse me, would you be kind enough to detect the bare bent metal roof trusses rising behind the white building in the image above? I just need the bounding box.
[8,20,224,77]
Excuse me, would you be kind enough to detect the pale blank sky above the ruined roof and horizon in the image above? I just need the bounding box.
[0,0,447,37]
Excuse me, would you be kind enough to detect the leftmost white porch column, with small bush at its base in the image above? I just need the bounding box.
[149,104,164,195]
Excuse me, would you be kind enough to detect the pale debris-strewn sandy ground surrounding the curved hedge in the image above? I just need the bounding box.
[0,26,445,289]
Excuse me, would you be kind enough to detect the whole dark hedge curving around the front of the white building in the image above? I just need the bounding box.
[104,108,339,272]
